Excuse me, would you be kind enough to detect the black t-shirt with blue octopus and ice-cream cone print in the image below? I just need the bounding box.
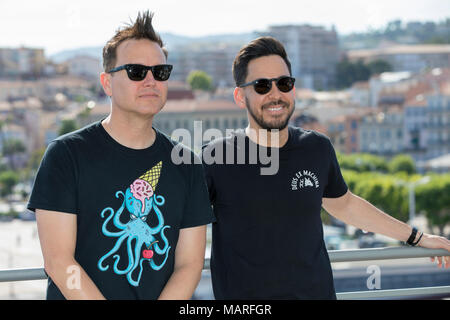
[28,122,214,299]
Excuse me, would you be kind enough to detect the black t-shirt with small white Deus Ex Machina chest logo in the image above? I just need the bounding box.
[203,127,347,299]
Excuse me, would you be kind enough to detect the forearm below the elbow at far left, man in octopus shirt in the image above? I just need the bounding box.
[45,257,105,300]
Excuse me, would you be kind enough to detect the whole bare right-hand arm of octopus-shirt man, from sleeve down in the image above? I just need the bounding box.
[159,225,206,300]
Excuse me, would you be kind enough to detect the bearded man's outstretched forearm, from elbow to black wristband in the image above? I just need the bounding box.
[330,194,411,241]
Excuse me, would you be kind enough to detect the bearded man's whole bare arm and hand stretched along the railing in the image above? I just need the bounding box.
[322,191,450,268]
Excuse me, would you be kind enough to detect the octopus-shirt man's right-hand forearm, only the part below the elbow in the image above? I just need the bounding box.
[158,264,203,300]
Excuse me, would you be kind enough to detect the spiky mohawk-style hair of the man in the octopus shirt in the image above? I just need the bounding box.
[103,10,168,72]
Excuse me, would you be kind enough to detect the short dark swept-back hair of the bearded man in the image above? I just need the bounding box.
[233,37,292,87]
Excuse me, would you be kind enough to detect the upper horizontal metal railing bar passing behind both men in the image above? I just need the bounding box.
[0,247,450,282]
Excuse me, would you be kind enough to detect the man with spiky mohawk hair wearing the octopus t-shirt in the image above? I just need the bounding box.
[28,11,214,299]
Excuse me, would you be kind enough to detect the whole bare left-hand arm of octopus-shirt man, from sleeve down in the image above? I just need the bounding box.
[36,209,104,300]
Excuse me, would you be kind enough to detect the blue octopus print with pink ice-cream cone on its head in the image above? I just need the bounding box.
[98,161,171,287]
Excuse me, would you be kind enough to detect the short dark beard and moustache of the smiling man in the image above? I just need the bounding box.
[245,97,295,131]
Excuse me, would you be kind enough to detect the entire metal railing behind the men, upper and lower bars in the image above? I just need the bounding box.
[0,247,450,300]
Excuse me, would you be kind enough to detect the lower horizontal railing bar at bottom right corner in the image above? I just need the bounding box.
[336,286,450,300]
